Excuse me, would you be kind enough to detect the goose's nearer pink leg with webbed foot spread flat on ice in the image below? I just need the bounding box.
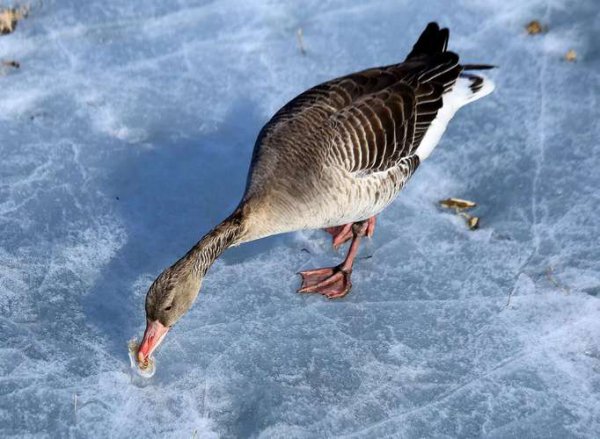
[298,220,370,299]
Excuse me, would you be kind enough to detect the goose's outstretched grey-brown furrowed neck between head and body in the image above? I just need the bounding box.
[177,209,245,278]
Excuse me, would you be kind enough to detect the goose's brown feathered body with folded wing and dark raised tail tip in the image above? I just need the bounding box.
[239,23,492,242]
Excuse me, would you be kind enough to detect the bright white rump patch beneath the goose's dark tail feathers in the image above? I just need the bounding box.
[416,73,495,161]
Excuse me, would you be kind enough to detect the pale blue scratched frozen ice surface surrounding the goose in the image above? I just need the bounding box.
[0,0,600,439]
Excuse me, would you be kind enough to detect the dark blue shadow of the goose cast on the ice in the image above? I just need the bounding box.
[82,101,289,359]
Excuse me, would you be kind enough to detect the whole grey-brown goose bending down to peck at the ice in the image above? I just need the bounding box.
[137,22,494,363]
